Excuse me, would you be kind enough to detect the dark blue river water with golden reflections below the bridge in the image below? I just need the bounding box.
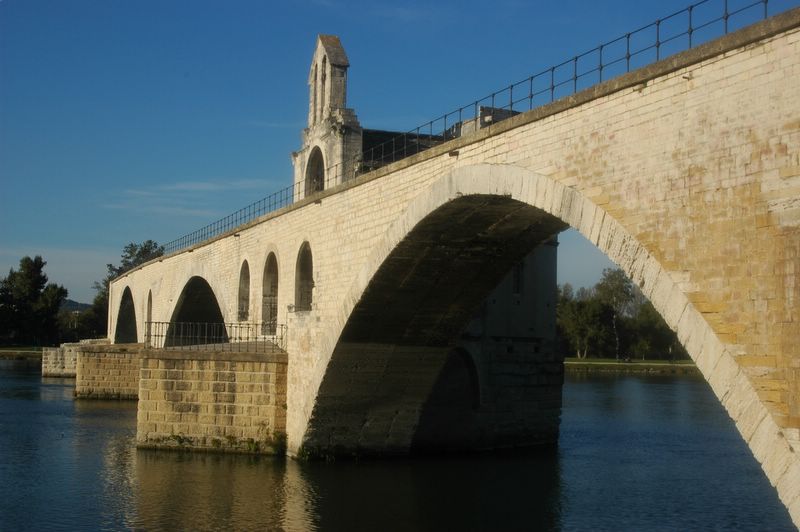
[0,361,795,531]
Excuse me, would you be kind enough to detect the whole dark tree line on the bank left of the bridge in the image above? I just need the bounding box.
[0,240,164,346]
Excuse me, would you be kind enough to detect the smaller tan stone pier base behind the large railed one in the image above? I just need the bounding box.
[75,344,142,399]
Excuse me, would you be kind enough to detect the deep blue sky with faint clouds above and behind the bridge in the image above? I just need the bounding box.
[0,0,797,302]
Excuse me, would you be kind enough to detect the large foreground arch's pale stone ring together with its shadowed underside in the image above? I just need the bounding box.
[287,164,800,505]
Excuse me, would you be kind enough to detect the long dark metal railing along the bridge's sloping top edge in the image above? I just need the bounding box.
[159,0,780,253]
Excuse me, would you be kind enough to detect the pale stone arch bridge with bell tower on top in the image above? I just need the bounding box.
[109,9,800,523]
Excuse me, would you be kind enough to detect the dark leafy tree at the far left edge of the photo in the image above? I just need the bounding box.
[0,255,67,345]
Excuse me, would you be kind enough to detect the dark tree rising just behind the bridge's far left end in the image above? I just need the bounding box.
[80,240,164,337]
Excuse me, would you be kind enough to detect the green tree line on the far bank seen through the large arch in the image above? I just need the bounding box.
[556,268,689,360]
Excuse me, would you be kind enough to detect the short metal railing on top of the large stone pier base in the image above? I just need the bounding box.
[145,321,286,353]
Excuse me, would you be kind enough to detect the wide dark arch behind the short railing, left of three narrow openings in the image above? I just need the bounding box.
[164,277,228,347]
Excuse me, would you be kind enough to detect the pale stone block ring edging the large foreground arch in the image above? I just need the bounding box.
[287,164,800,511]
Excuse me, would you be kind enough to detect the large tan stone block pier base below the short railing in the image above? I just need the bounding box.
[136,351,287,454]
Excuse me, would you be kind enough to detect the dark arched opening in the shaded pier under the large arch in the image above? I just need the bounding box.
[412,348,481,452]
